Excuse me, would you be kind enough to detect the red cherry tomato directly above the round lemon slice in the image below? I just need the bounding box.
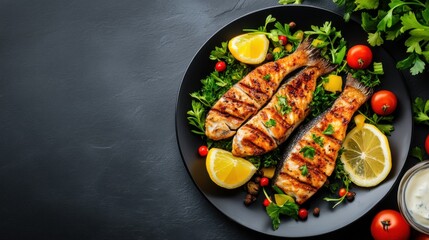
[371,90,398,116]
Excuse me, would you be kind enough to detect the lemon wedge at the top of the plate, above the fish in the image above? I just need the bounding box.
[228,33,270,64]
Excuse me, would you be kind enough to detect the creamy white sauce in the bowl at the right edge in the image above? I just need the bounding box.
[405,168,429,229]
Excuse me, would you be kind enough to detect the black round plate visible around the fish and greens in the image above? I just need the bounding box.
[176,5,412,237]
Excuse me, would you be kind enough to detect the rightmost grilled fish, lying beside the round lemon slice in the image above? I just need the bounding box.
[273,74,372,204]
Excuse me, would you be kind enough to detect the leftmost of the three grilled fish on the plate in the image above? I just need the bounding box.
[205,40,321,140]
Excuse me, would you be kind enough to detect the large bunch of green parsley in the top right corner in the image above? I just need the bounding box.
[334,0,429,75]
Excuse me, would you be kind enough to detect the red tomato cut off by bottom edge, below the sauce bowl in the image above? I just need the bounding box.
[371,209,410,240]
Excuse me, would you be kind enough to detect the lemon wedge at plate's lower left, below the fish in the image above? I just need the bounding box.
[206,148,256,189]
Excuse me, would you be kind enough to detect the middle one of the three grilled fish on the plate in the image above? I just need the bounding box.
[232,58,335,157]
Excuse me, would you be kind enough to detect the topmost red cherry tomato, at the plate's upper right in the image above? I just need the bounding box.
[346,45,372,69]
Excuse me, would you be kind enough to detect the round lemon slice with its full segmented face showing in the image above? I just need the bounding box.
[341,123,392,187]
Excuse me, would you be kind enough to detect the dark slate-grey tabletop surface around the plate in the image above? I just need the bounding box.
[0,0,429,239]
